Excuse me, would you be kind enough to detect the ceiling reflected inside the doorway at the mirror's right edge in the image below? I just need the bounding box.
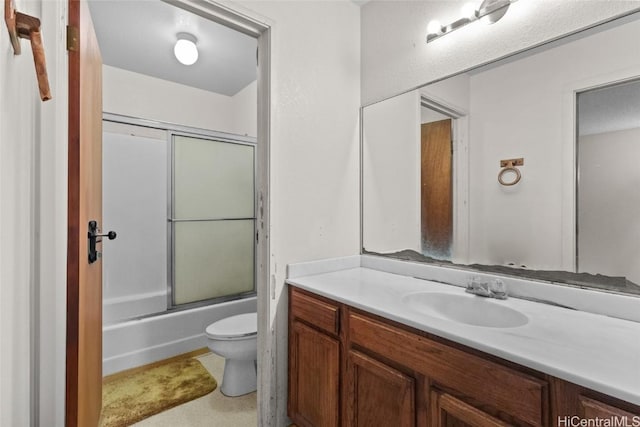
[578,80,640,135]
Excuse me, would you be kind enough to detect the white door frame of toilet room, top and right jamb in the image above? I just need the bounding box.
[62,0,278,426]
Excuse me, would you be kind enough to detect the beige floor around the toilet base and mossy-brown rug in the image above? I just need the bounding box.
[134,353,258,427]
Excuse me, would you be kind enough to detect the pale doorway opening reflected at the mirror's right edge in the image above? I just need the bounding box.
[576,80,640,283]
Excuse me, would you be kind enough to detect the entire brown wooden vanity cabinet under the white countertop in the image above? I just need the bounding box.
[289,287,640,427]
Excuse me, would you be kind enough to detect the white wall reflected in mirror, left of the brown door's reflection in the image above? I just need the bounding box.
[362,90,420,253]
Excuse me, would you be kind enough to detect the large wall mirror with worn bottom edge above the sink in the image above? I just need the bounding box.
[362,13,640,294]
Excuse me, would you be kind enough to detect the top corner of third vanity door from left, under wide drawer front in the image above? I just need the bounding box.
[430,391,510,427]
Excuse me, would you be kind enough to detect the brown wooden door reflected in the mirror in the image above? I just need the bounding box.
[420,115,453,259]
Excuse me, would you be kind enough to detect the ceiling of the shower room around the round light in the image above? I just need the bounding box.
[89,0,257,96]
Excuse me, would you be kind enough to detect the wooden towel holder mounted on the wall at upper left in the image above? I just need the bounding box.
[4,0,51,101]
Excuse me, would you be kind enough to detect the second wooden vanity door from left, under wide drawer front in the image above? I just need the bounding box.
[345,350,416,427]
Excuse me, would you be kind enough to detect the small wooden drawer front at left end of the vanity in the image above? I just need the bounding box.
[289,287,340,335]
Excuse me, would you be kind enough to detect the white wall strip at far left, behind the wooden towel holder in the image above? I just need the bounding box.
[0,2,41,427]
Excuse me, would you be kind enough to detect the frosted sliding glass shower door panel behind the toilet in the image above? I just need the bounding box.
[174,135,256,307]
